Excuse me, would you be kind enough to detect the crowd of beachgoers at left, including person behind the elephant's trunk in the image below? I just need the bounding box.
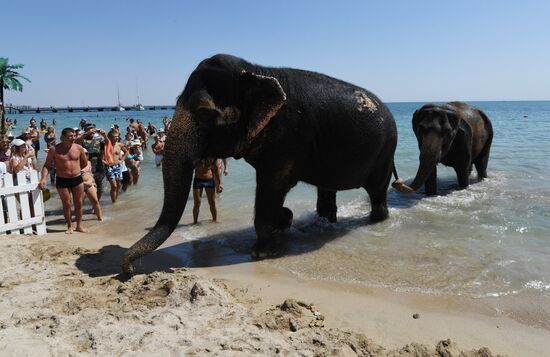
[0,117,229,233]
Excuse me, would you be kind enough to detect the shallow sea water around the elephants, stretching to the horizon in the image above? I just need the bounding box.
[9,101,550,317]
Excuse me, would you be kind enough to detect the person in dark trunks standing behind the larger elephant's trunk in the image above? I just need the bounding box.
[193,159,219,224]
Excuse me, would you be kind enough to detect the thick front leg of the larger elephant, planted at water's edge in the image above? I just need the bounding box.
[251,174,292,258]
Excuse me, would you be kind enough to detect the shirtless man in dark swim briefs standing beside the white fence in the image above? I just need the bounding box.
[38,128,88,234]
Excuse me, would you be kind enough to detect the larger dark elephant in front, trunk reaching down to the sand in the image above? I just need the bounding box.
[123,54,397,273]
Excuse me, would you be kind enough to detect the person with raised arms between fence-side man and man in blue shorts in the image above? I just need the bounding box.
[75,123,109,200]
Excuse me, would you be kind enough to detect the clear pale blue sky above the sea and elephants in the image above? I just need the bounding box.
[4,0,550,106]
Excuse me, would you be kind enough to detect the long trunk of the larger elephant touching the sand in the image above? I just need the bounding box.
[122,110,199,274]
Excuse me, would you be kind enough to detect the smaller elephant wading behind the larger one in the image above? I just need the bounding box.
[401,102,493,195]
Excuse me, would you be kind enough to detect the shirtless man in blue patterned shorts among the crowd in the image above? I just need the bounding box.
[103,129,127,203]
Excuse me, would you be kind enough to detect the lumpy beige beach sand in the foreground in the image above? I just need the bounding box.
[0,211,550,356]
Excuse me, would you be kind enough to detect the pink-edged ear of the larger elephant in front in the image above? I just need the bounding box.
[239,71,286,140]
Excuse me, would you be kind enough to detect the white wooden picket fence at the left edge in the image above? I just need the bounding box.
[0,170,46,235]
